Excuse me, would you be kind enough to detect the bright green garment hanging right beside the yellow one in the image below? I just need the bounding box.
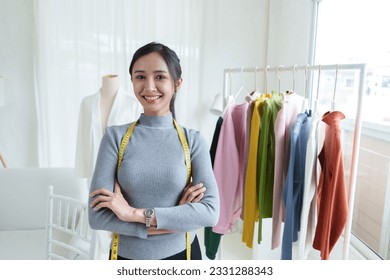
[257,93,283,244]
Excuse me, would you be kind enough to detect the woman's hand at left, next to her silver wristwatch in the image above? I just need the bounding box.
[90,181,136,222]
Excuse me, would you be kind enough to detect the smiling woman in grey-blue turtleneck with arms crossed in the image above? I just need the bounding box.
[89,43,219,259]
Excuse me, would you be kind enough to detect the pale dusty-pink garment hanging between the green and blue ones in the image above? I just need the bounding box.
[271,92,304,249]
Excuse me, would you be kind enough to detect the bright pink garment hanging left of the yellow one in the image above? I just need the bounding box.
[213,102,248,234]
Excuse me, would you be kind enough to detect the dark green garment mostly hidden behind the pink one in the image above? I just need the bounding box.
[204,117,223,260]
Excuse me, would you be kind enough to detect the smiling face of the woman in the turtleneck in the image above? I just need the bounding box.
[131,52,181,116]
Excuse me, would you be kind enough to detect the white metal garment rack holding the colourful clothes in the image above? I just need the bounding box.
[223,64,367,260]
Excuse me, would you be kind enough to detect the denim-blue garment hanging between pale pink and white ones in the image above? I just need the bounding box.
[282,113,311,260]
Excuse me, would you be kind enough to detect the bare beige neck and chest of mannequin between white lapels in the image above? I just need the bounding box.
[100,74,120,131]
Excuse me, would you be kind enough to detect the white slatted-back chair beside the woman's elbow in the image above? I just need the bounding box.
[46,186,96,260]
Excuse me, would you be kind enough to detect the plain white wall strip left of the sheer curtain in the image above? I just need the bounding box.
[0,0,38,167]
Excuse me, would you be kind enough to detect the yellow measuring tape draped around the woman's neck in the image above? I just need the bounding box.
[110,119,191,260]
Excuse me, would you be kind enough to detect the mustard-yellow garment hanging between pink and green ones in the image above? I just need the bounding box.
[242,94,267,248]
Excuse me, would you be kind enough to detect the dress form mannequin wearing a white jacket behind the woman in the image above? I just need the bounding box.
[74,74,142,260]
